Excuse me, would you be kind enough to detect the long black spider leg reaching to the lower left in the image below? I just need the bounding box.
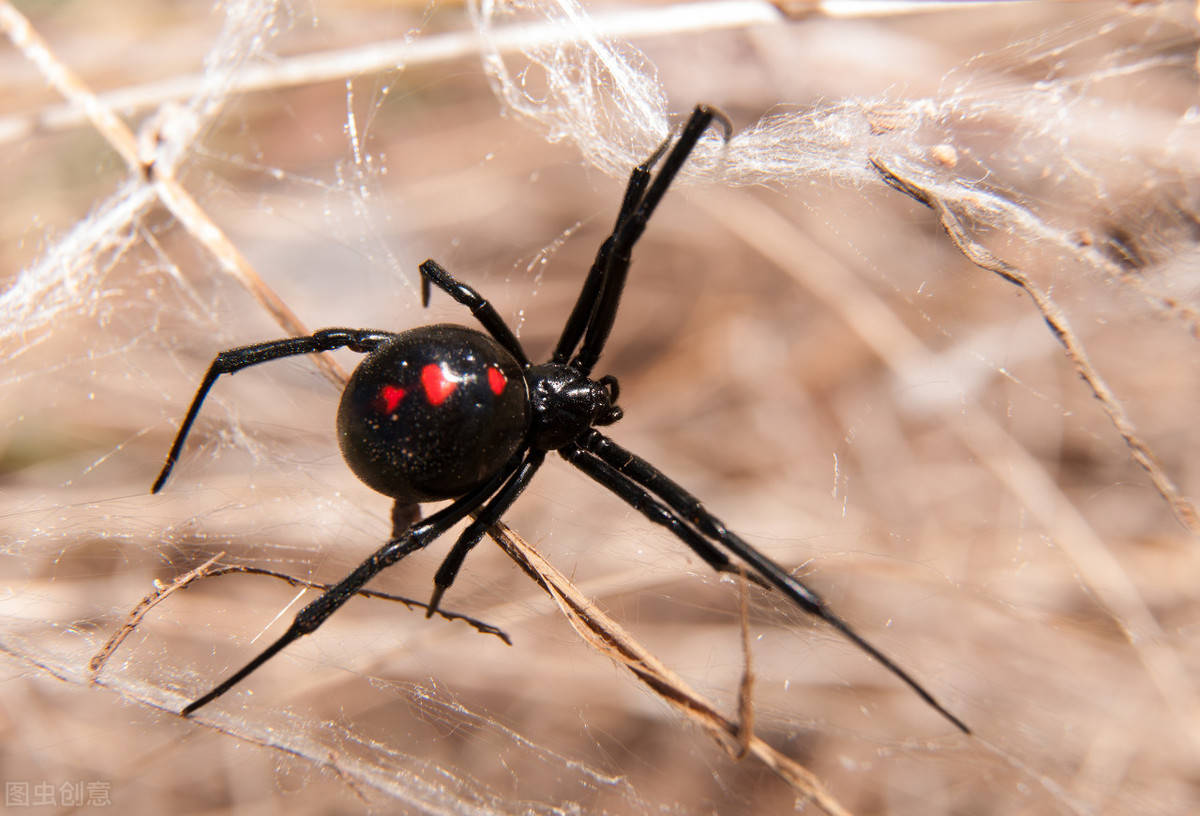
[180,457,518,716]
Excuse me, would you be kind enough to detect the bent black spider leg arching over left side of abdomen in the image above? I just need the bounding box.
[150,329,395,493]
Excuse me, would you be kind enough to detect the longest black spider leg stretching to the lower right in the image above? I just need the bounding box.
[566,430,971,734]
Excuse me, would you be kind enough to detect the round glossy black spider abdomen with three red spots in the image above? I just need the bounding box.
[337,324,529,502]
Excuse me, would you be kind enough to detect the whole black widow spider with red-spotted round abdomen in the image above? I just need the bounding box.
[151,106,971,733]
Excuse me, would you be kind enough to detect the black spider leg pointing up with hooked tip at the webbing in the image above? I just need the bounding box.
[560,104,733,374]
